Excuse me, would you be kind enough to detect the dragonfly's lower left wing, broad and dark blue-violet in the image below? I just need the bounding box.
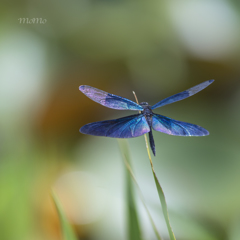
[80,114,150,138]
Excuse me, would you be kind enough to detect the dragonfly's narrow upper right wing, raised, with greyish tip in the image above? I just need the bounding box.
[151,80,214,109]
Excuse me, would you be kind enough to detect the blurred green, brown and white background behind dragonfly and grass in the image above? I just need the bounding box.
[0,0,240,240]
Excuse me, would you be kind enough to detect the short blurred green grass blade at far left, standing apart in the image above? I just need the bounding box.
[52,192,79,240]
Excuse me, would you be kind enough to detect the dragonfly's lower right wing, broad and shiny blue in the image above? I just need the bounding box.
[152,114,209,136]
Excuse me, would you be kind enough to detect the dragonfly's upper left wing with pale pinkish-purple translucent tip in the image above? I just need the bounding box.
[79,85,143,111]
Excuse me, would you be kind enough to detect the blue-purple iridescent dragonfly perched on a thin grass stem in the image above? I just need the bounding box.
[79,80,214,156]
